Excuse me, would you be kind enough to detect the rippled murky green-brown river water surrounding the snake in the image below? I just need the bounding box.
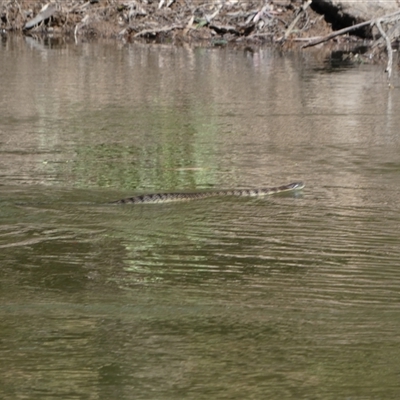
[0,38,400,399]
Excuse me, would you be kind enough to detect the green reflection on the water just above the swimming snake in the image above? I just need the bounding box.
[67,102,218,190]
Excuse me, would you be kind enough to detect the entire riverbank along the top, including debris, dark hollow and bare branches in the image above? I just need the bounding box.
[0,0,400,77]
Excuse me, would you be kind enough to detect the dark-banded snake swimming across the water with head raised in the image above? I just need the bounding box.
[109,182,304,204]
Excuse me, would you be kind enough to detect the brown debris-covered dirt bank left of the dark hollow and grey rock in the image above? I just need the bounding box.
[0,0,354,45]
